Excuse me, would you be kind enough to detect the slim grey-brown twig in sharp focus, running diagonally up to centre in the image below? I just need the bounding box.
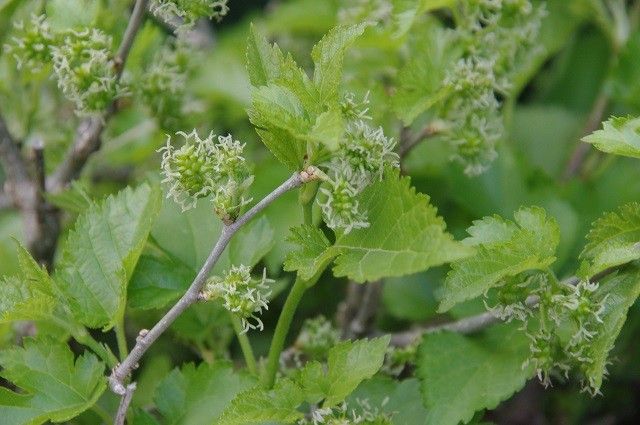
[109,167,315,395]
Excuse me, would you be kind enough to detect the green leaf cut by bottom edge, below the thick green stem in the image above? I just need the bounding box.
[216,379,304,425]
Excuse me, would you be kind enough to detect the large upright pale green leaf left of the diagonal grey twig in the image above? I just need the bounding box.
[55,184,161,328]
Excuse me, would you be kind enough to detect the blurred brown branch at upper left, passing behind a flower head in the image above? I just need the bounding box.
[47,0,149,193]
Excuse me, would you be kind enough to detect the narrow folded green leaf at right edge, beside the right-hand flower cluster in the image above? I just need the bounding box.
[586,269,640,392]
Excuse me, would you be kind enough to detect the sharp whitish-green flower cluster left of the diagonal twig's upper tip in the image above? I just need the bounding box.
[159,129,253,217]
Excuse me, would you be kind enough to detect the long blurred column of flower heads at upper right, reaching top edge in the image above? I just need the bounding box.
[439,0,545,175]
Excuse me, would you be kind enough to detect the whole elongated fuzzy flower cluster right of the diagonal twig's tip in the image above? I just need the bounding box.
[318,94,399,233]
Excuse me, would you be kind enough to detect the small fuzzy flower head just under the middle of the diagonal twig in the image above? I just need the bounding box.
[202,265,273,333]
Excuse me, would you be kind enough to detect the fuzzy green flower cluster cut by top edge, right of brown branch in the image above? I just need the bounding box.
[150,0,229,32]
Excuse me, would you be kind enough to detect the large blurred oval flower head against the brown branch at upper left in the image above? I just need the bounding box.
[51,29,124,115]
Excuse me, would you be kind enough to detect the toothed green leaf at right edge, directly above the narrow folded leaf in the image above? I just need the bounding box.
[579,202,640,278]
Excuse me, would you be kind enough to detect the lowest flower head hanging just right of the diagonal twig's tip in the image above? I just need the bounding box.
[318,171,369,234]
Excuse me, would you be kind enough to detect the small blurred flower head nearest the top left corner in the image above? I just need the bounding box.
[5,15,56,73]
